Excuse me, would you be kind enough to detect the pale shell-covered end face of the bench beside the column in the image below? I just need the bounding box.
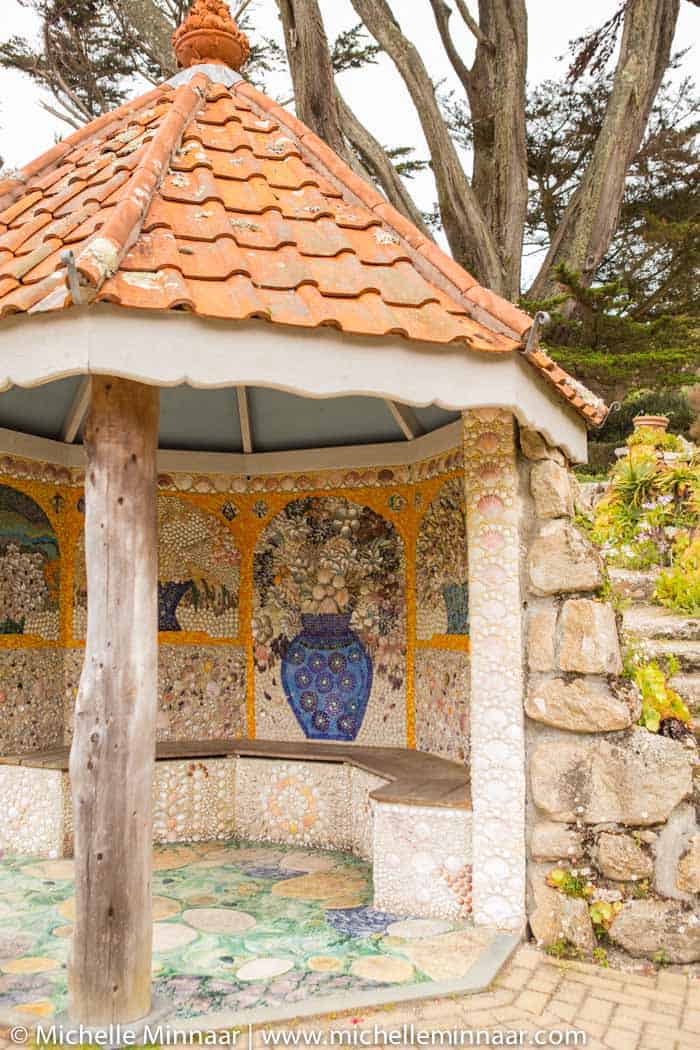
[374,802,471,919]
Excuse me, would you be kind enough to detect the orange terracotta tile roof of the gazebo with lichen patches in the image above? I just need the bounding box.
[0,4,607,425]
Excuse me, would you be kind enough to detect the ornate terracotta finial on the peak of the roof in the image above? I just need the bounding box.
[172,0,251,72]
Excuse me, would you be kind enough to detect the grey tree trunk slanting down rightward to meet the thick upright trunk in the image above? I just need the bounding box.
[352,0,503,292]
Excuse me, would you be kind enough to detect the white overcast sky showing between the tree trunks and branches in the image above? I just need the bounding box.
[0,0,700,281]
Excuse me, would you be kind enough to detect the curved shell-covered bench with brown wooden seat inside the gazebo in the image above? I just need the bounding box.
[0,740,471,919]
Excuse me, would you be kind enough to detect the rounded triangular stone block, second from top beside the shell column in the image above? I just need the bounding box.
[529,519,602,594]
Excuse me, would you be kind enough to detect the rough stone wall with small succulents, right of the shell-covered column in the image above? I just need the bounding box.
[521,431,700,962]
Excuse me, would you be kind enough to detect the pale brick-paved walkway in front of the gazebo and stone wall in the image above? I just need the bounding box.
[0,947,700,1050]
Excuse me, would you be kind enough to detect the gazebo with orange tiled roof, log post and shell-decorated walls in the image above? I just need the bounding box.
[0,0,607,1024]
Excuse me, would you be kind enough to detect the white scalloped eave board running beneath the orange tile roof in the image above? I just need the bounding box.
[0,305,587,462]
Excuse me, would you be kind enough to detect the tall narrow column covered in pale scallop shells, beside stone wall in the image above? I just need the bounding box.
[463,408,526,931]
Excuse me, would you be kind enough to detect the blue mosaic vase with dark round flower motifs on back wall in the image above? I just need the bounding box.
[282,613,373,740]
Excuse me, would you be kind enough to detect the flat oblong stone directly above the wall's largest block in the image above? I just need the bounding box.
[525,678,632,733]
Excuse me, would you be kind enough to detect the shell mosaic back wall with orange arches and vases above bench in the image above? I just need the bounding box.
[0,449,469,761]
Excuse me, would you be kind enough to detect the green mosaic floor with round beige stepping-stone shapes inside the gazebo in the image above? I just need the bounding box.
[0,842,503,1023]
